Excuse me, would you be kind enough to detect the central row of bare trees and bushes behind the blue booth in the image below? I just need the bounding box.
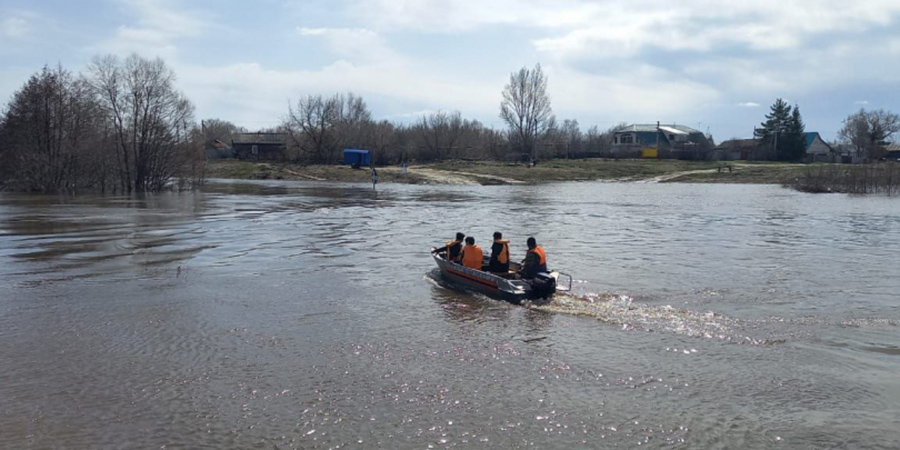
[278,65,611,164]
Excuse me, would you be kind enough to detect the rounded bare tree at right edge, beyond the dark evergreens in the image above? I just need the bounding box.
[838,109,900,159]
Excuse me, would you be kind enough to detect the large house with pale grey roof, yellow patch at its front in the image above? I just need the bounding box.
[611,123,712,159]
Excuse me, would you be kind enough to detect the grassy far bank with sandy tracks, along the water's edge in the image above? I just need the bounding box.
[207,159,806,185]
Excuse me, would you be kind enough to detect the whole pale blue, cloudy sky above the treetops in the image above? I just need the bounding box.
[0,0,900,142]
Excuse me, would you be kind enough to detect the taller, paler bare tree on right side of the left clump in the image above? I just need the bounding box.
[90,54,194,192]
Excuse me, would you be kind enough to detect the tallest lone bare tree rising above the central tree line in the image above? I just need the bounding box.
[500,64,553,159]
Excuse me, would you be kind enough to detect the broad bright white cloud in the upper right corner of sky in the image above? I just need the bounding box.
[534,0,900,58]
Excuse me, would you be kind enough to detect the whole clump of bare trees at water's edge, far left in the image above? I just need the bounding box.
[0,55,204,193]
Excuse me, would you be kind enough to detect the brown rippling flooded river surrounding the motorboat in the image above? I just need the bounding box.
[0,182,900,449]
